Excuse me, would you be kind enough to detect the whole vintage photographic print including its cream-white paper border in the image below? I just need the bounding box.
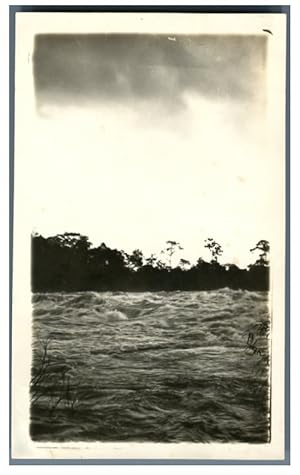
[12,12,286,460]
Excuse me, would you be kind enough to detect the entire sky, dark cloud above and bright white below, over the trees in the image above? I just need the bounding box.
[29,34,276,267]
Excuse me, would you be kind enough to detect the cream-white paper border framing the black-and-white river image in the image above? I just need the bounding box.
[12,13,286,460]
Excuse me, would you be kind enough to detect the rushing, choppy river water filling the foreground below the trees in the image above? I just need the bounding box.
[31,289,270,443]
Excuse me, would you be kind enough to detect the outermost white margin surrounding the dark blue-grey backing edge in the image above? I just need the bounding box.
[0,0,300,474]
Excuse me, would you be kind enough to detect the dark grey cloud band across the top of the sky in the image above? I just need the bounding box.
[34,34,266,107]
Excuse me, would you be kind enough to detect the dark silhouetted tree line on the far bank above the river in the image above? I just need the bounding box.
[31,233,270,292]
